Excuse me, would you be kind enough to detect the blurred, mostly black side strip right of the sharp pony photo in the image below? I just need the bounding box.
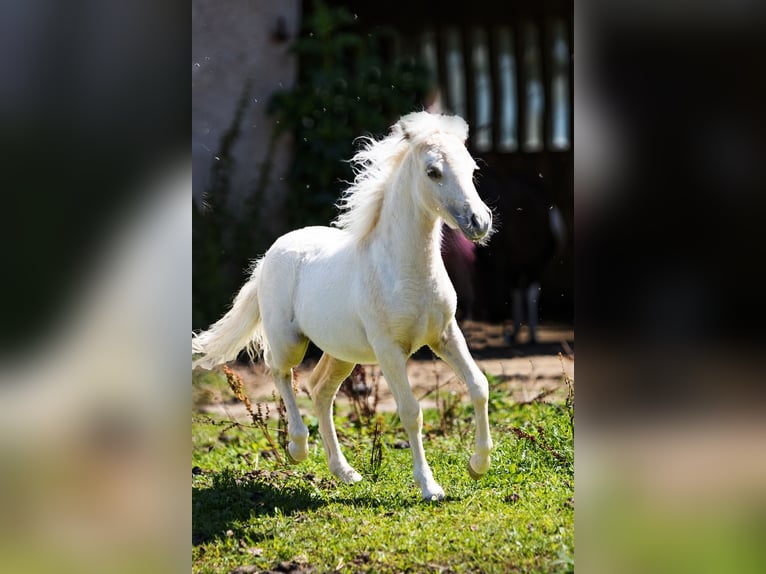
[574,0,766,573]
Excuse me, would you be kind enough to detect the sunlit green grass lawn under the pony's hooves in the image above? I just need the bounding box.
[192,368,574,573]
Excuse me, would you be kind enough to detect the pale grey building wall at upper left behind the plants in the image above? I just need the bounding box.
[192,0,300,234]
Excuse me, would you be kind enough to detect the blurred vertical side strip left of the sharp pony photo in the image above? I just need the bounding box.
[0,0,191,573]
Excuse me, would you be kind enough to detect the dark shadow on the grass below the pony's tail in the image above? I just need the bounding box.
[192,475,326,545]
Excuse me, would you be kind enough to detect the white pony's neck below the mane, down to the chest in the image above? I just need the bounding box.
[370,169,444,275]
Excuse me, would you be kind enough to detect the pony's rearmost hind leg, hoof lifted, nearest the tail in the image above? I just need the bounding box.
[264,339,309,462]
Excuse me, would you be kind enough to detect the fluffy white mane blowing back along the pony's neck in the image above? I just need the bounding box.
[333,112,468,239]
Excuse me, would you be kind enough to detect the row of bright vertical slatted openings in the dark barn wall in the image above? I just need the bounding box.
[396,13,572,153]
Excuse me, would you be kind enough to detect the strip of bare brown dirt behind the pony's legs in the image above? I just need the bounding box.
[194,322,574,420]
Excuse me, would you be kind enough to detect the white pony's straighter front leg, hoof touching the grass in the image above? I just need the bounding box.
[373,341,444,500]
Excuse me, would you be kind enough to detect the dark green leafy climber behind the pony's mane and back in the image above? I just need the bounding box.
[269,2,430,227]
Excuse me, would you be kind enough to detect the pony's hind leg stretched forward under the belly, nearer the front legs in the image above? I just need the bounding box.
[309,353,362,484]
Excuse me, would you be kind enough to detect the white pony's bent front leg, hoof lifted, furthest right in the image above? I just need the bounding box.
[431,319,492,480]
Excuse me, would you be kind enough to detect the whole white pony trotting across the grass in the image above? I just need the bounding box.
[192,112,492,500]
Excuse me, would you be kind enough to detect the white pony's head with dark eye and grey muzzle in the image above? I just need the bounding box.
[400,112,492,245]
